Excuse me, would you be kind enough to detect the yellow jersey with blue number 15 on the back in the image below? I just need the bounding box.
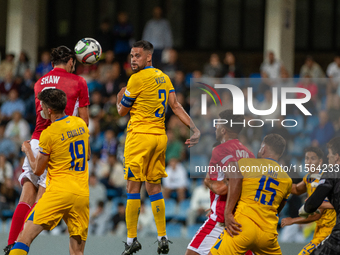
[235,158,292,234]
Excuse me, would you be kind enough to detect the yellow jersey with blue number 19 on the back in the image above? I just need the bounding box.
[39,115,89,196]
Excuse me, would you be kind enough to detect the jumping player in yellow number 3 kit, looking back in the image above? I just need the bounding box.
[117,40,200,255]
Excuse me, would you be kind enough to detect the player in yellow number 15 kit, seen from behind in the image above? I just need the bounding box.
[209,134,292,255]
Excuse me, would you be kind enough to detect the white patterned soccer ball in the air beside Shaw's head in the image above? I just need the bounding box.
[74,37,102,65]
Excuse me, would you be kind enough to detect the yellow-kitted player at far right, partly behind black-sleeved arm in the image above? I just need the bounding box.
[281,147,336,255]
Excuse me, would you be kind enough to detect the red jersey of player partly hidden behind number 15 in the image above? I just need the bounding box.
[209,139,255,223]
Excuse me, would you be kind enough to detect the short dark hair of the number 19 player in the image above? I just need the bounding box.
[38,89,67,113]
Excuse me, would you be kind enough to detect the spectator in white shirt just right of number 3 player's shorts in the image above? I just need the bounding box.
[163,158,188,202]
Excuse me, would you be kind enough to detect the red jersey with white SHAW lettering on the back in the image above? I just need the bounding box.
[32,68,90,140]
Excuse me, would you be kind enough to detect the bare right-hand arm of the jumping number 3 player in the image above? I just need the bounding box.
[168,92,201,148]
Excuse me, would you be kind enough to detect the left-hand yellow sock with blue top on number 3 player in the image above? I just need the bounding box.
[125,193,140,238]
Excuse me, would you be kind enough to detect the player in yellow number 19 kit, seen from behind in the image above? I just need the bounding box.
[10,89,90,255]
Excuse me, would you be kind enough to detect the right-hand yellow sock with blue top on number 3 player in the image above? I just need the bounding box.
[150,192,166,236]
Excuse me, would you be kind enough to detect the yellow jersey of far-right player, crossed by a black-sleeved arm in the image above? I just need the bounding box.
[303,173,336,227]
